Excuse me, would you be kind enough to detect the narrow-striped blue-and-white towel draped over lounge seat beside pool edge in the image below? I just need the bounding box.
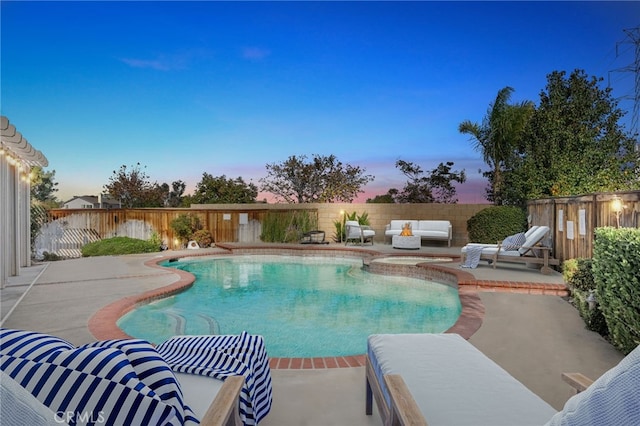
[157,332,273,425]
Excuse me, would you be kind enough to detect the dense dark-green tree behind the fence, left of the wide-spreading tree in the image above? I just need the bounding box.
[191,173,258,204]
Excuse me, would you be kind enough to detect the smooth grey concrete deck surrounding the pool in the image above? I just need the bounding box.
[0,244,623,426]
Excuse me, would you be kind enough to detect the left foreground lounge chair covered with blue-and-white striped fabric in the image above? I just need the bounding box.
[0,329,271,426]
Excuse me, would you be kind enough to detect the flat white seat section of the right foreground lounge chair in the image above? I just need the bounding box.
[366,334,556,426]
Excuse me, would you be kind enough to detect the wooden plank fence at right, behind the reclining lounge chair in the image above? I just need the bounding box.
[527,191,640,261]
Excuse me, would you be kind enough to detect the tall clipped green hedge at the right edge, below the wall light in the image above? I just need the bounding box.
[593,228,640,354]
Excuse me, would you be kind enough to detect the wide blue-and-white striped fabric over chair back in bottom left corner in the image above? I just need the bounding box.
[0,329,198,425]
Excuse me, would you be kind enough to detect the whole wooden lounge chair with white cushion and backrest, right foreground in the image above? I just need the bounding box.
[366,334,640,426]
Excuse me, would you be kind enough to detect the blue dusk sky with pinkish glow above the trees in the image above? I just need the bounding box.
[0,1,640,202]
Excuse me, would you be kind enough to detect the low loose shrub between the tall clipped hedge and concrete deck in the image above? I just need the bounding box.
[562,258,609,336]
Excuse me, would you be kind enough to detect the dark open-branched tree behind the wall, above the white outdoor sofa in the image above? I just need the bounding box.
[389,160,467,204]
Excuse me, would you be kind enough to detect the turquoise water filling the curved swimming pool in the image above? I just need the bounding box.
[118,255,462,357]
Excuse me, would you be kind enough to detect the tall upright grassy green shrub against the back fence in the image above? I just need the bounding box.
[260,210,318,243]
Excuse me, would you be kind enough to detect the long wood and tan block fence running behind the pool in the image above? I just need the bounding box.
[42,203,488,253]
